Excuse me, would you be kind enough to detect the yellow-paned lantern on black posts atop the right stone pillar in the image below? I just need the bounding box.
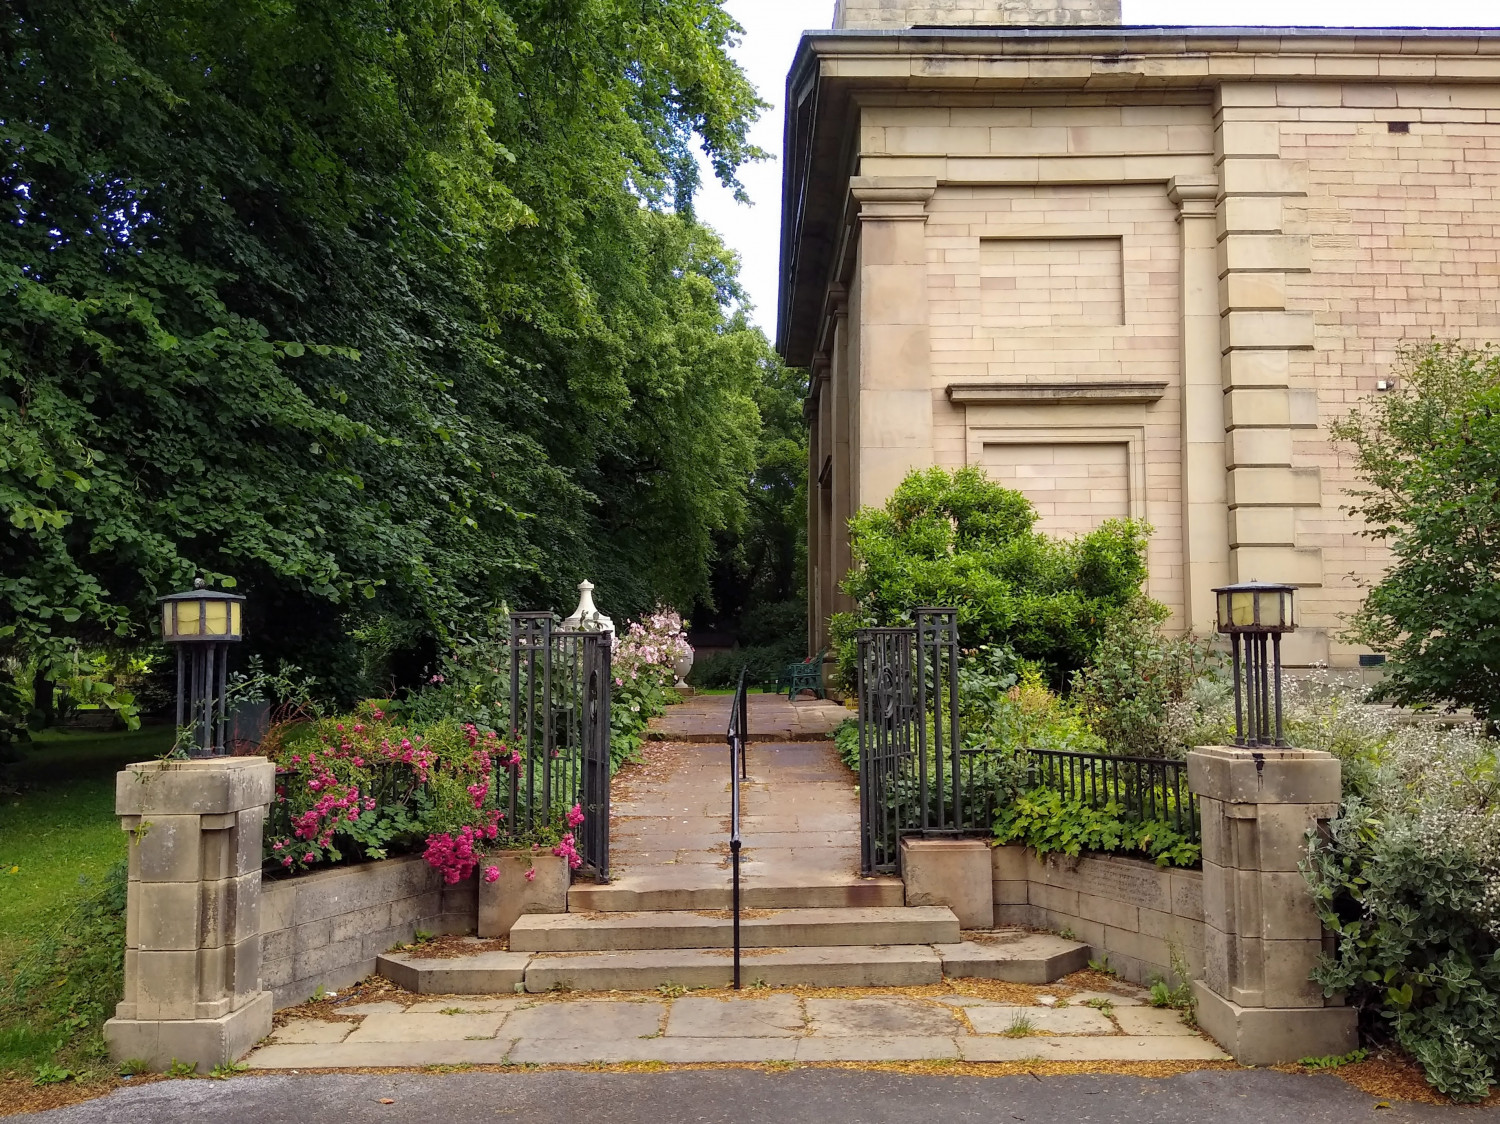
[1214,582,1296,746]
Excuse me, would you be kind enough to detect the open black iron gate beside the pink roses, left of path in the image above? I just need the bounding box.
[509,612,614,882]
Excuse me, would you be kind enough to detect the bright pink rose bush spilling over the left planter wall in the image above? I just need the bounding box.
[264,704,584,885]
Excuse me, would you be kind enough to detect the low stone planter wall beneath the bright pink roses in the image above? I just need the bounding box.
[261,855,479,1010]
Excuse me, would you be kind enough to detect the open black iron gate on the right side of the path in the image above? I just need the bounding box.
[855,608,993,873]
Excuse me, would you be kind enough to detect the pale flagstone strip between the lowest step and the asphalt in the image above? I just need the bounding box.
[248,984,1226,1068]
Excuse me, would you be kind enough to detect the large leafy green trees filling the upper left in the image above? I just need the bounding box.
[0,0,779,699]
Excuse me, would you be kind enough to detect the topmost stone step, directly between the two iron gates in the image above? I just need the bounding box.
[567,867,906,914]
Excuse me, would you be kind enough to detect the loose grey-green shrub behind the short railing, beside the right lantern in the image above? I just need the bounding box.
[1071,597,1218,758]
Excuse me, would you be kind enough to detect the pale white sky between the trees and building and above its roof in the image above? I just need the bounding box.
[698,0,1500,338]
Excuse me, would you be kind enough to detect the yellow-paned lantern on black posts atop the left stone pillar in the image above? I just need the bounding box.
[158,578,245,756]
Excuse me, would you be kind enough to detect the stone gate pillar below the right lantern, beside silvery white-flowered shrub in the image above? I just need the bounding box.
[1188,746,1358,1065]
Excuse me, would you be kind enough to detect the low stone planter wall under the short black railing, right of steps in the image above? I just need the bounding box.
[992,845,1203,984]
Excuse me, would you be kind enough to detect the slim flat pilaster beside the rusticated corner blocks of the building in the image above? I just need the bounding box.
[1167,176,1229,636]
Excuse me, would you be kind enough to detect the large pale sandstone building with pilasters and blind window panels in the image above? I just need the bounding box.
[777,0,1500,665]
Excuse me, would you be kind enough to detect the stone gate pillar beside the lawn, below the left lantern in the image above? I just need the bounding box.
[104,758,275,1071]
